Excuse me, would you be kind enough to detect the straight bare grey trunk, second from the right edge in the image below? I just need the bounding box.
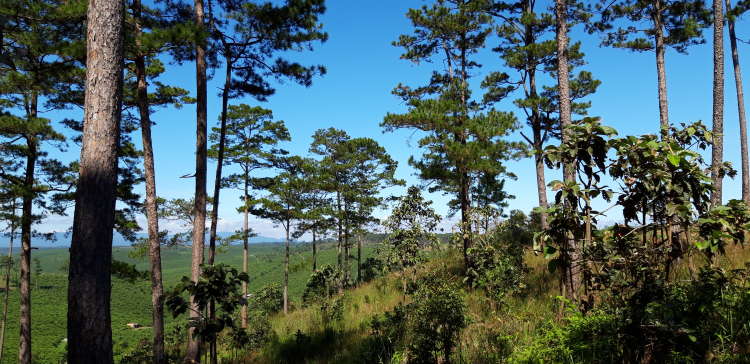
[711,0,724,206]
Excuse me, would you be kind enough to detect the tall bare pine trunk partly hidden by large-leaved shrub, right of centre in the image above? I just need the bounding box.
[555,0,581,301]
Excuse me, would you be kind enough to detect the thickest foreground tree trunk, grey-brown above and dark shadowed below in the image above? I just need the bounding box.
[68,0,125,364]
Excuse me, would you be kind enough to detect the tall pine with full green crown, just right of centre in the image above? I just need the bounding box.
[381,0,522,278]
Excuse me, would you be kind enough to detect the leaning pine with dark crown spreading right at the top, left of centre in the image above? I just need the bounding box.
[208,0,328,264]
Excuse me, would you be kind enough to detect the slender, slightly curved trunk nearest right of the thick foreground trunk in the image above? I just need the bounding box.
[133,0,164,362]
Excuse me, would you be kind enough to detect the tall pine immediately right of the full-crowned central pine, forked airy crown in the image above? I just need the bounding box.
[485,0,600,229]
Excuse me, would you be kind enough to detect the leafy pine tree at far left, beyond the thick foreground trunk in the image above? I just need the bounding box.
[0,1,82,363]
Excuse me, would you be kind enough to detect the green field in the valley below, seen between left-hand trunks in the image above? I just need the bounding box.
[2,243,377,363]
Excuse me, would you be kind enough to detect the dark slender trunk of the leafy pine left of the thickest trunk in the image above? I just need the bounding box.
[18,92,39,364]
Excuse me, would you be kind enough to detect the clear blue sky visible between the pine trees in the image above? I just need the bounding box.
[32,0,750,242]
